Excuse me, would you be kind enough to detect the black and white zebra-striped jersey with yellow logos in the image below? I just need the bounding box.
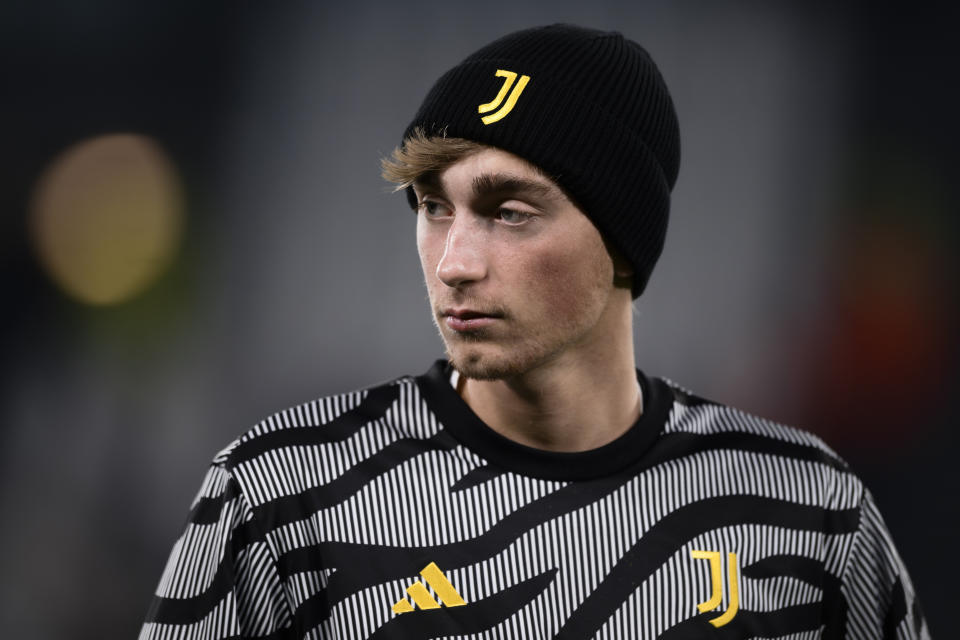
[140,361,929,640]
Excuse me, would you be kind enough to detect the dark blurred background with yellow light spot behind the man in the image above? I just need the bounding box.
[0,0,960,640]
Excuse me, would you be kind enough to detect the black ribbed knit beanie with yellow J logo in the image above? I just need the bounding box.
[404,24,680,297]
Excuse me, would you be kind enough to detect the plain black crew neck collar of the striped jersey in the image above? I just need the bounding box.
[416,360,672,480]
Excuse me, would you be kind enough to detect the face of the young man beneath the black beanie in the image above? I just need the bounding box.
[414,148,630,379]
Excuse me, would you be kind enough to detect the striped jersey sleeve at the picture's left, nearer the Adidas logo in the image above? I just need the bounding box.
[140,464,291,640]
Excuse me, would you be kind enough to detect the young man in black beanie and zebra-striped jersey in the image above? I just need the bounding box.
[141,25,928,639]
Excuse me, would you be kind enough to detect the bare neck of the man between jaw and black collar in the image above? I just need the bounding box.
[459,290,642,452]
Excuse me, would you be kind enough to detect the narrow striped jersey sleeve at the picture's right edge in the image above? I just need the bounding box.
[841,492,930,640]
